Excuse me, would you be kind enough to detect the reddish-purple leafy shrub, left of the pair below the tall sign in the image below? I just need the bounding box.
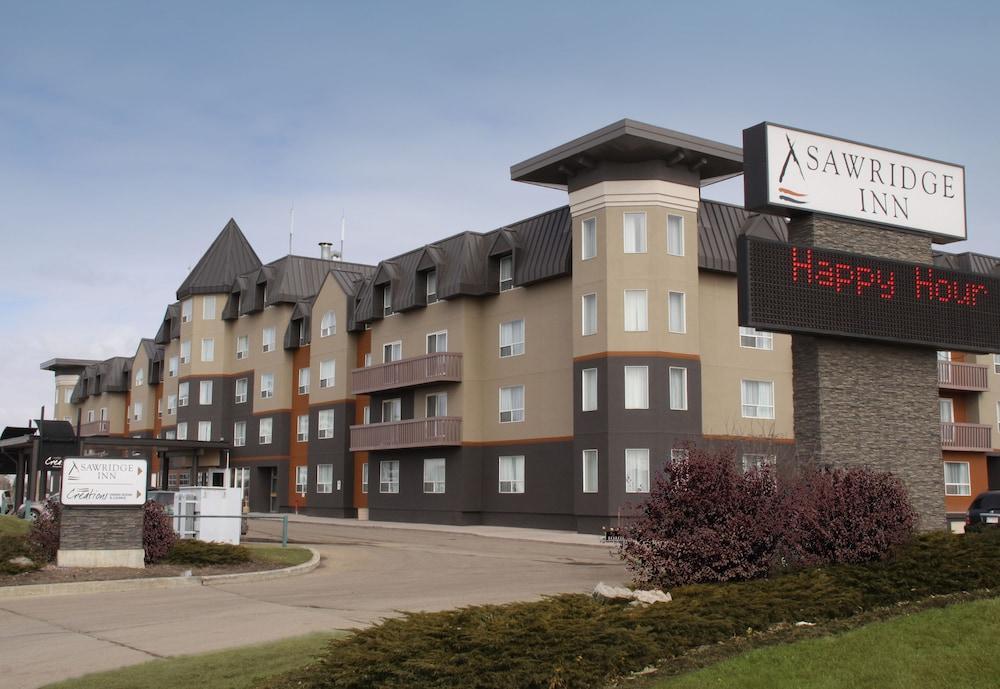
[619,448,780,587]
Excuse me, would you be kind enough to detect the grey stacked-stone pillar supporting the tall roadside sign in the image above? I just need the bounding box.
[788,215,945,530]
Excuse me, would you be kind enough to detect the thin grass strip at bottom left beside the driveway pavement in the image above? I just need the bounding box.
[45,634,334,689]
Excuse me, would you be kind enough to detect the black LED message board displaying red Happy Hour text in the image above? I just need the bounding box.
[737,236,1000,353]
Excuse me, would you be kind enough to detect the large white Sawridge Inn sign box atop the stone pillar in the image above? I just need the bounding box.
[743,122,966,243]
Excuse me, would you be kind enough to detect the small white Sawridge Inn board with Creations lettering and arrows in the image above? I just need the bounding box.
[61,457,149,506]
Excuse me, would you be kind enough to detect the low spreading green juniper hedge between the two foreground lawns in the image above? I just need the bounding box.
[264,530,1000,689]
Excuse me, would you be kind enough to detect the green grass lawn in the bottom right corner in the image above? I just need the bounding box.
[651,599,1000,689]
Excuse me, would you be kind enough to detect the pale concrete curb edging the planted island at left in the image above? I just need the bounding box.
[0,546,320,601]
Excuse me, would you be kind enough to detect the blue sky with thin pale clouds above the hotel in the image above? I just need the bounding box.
[0,0,1000,427]
